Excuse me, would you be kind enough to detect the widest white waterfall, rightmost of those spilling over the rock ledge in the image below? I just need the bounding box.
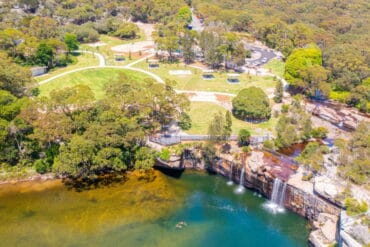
[264,178,286,214]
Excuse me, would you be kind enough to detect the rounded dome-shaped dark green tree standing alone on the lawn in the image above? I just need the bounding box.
[232,87,271,120]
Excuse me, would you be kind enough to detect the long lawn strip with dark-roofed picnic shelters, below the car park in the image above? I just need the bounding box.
[134,61,276,94]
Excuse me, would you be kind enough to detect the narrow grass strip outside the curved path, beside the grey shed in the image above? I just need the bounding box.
[35,53,99,82]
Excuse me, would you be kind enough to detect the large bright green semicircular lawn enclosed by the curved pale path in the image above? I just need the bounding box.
[39,68,148,99]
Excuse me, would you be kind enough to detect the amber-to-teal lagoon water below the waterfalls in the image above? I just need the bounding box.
[0,171,309,247]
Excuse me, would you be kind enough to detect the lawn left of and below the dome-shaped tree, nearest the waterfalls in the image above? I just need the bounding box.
[186,102,277,135]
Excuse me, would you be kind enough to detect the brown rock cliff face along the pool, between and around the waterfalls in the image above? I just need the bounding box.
[153,152,340,246]
